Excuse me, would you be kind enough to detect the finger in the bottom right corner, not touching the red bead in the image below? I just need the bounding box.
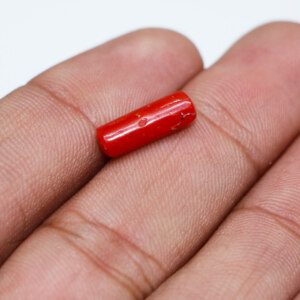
[150,138,300,300]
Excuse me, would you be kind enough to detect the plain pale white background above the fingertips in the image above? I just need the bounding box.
[0,0,300,97]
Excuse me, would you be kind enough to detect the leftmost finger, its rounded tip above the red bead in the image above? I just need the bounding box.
[0,29,201,263]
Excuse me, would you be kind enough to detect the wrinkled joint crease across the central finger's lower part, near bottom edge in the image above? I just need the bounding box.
[44,210,165,299]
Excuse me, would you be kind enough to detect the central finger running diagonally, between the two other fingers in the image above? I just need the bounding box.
[0,24,300,299]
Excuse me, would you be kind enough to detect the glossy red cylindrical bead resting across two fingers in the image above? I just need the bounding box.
[97,92,196,157]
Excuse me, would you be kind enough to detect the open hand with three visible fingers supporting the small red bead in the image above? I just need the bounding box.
[0,23,300,299]
